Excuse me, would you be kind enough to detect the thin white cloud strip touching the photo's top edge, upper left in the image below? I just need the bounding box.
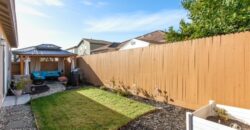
[18,0,64,6]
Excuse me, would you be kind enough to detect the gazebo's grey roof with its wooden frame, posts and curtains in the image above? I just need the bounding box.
[12,44,77,75]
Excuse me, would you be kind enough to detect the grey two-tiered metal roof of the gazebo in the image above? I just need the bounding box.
[12,44,76,57]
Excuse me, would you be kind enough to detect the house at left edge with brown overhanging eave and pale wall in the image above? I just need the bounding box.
[0,0,18,107]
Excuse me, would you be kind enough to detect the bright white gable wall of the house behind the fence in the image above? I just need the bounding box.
[120,39,150,50]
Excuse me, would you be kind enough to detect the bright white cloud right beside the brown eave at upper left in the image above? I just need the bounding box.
[16,4,48,17]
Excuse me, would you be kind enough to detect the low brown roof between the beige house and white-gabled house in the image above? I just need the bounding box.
[91,43,120,54]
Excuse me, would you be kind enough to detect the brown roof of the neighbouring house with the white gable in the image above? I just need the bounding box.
[118,30,166,49]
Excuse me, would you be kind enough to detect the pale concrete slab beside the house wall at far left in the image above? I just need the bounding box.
[3,94,31,107]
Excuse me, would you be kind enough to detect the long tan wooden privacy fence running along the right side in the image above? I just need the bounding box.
[78,32,250,109]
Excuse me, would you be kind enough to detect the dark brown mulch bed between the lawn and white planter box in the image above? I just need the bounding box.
[120,96,192,130]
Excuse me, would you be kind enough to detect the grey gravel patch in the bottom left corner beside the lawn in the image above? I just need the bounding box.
[0,105,36,130]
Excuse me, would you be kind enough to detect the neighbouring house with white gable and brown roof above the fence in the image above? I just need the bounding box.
[118,30,166,50]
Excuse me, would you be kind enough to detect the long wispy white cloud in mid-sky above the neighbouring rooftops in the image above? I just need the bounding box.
[84,10,186,33]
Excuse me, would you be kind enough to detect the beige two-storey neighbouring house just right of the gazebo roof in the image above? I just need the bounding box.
[66,38,111,56]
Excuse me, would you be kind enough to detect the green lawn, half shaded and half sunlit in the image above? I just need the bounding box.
[31,87,155,130]
